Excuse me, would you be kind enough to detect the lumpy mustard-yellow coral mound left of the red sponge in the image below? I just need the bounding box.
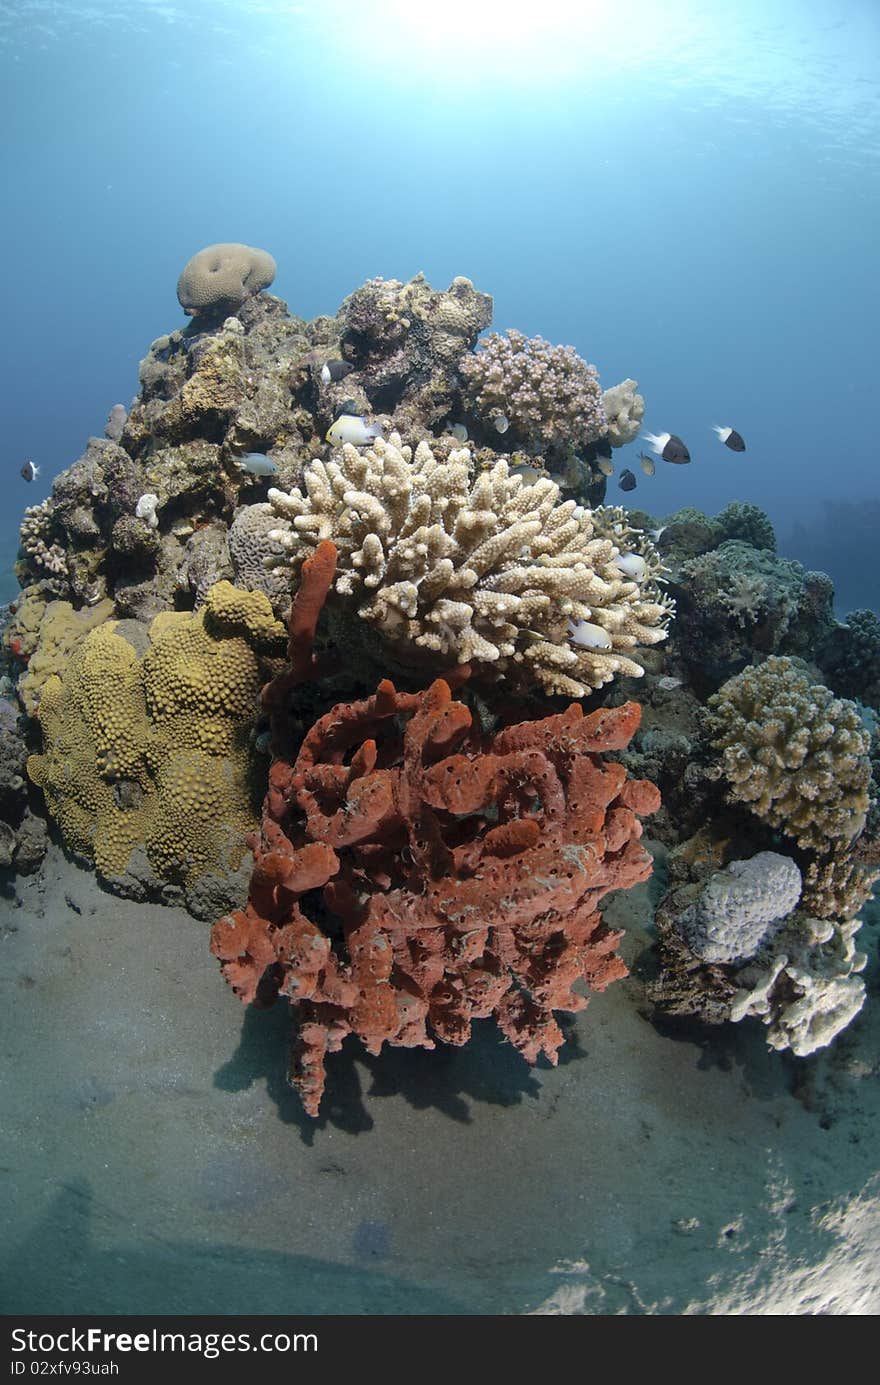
[28,583,283,886]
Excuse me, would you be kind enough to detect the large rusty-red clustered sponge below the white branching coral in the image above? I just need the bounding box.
[211,680,658,1115]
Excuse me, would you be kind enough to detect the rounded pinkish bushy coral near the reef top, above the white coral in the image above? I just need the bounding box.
[460,331,608,464]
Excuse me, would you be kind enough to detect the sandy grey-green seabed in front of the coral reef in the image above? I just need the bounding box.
[0,848,880,1314]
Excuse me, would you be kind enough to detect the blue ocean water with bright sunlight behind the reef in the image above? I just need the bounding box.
[0,0,880,609]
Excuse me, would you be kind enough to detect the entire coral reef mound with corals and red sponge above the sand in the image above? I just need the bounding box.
[0,257,880,1080]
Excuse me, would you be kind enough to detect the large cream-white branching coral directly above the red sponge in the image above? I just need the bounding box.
[267,434,671,697]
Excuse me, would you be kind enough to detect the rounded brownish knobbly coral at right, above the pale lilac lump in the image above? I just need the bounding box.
[710,658,870,855]
